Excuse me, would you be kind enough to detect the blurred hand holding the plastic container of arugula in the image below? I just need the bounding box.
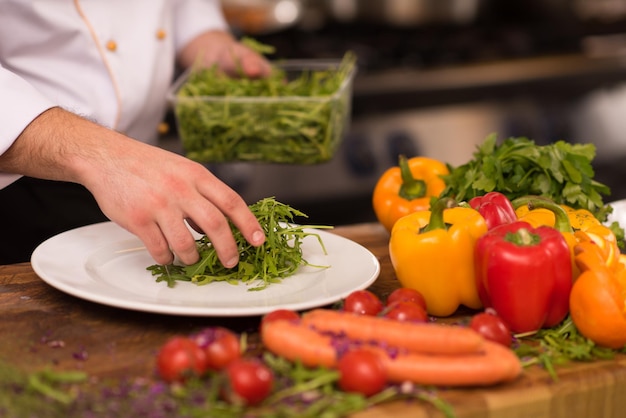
[178,31,271,78]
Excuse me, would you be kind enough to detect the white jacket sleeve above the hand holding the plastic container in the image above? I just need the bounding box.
[174,0,229,51]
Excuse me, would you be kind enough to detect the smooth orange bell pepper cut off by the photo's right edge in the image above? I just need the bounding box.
[570,241,626,349]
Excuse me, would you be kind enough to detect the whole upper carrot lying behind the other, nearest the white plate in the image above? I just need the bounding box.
[302,309,485,354]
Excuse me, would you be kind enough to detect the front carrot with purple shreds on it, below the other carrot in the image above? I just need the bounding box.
[261,321,522,386]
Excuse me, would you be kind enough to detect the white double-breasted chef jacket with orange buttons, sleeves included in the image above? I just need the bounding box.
[0,0,227,188]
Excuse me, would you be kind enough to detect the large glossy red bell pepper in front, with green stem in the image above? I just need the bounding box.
[474,221,572,333]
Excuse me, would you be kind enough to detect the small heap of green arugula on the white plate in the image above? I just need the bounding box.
[148,198,332,290]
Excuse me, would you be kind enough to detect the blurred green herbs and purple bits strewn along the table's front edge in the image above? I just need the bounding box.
[18,352,456,418]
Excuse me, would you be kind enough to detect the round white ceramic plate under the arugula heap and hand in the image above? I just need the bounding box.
[31,222,380,316]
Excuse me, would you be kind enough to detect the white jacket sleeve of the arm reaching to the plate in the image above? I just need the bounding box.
[0,66,55,188]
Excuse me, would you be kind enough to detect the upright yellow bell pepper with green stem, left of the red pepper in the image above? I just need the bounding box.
[389,198,487,317]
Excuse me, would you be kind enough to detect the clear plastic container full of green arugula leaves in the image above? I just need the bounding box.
[174,49,356,164]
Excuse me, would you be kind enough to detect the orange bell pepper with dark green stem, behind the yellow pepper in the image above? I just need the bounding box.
[372,155,449,232]
